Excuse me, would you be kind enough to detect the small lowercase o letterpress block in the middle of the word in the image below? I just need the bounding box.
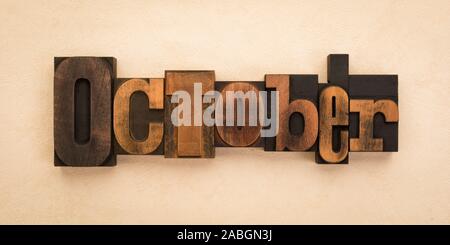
[214,81,265,147]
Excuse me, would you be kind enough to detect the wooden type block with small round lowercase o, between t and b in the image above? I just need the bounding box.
[215,81,264,147]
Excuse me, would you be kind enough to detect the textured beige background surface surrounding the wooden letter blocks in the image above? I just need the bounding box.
[0,0,450,224]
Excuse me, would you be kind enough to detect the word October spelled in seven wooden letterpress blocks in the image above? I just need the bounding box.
[54,54,399,166]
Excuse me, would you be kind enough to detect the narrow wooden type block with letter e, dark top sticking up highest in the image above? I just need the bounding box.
[316,54,349,163]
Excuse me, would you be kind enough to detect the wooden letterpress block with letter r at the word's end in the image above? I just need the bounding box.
[349,75,399,151]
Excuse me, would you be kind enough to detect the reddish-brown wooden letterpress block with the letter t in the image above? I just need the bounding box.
[164,71,215,158]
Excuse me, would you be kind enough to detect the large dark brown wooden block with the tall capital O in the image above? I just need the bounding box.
[54,57,116,166]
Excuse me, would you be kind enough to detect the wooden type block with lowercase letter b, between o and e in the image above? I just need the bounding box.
[264,75,319,151]
